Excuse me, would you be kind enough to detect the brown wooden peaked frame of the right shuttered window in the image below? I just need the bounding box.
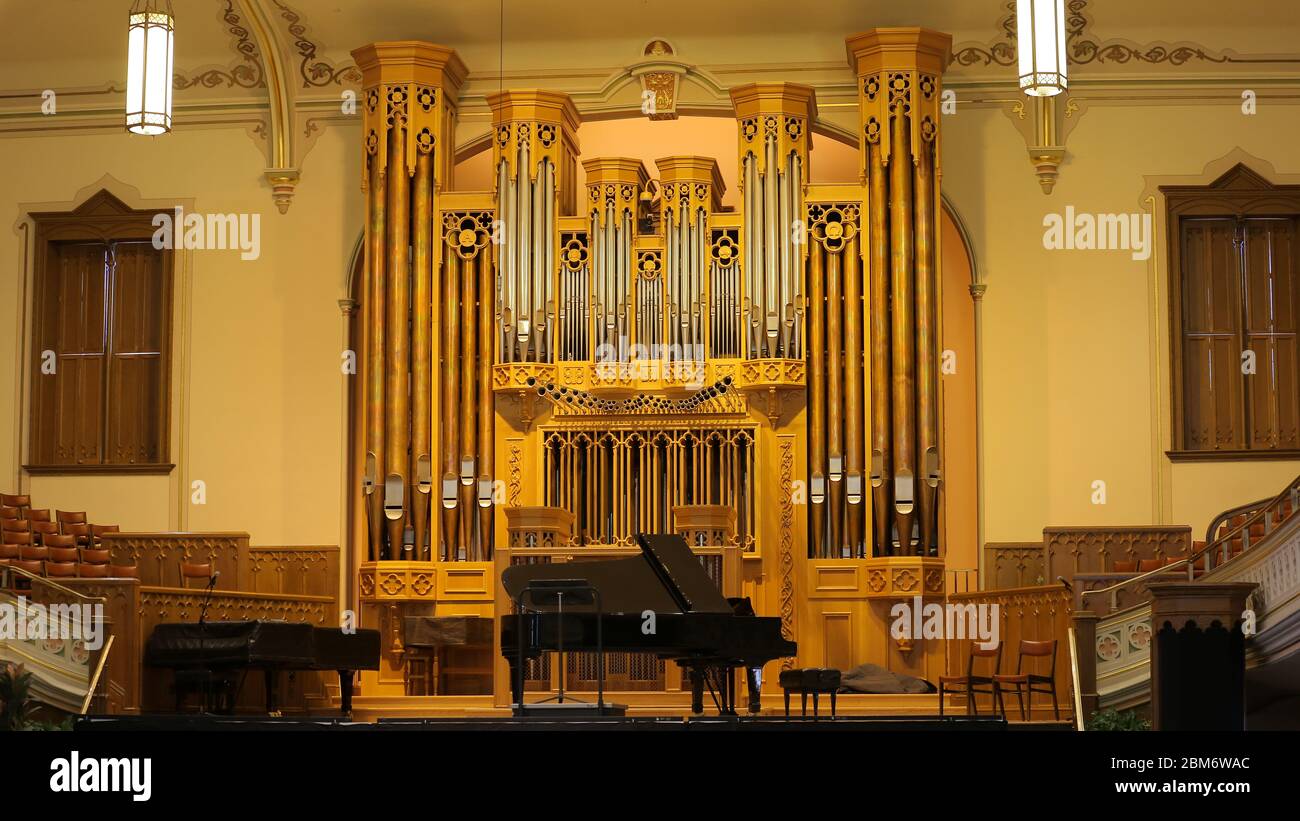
[1160,164,1300,462]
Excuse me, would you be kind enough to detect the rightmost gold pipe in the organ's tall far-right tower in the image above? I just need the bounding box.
[914,140,939,555]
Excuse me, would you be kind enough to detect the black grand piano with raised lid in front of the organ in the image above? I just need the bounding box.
[501,534,796,714]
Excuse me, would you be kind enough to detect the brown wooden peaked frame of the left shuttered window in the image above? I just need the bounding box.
[22,190,176,475]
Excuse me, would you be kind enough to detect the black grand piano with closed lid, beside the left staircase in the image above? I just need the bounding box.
[144,621,380,716]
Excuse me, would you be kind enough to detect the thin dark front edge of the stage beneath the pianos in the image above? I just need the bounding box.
[73,713,1073,733]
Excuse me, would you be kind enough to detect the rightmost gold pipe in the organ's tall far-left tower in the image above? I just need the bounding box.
[408,153,433,560]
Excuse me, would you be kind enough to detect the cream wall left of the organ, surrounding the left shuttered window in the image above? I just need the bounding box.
[0,127,361,544]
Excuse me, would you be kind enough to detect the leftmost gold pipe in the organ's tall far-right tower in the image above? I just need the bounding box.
[867,143,893,555]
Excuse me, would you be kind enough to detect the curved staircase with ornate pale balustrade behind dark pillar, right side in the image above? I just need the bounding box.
[1080,477,1300,726]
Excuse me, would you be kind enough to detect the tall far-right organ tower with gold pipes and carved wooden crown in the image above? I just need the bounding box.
[846,29,952,555]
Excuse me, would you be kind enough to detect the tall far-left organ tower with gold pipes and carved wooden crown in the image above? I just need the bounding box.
[352,42,467,561]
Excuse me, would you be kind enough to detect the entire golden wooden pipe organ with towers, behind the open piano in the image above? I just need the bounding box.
[348,29,950,714]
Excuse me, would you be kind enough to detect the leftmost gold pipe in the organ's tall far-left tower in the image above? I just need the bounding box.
[363,156,387,561]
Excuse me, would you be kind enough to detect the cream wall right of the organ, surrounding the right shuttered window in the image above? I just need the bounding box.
[943,97,1300,542]
